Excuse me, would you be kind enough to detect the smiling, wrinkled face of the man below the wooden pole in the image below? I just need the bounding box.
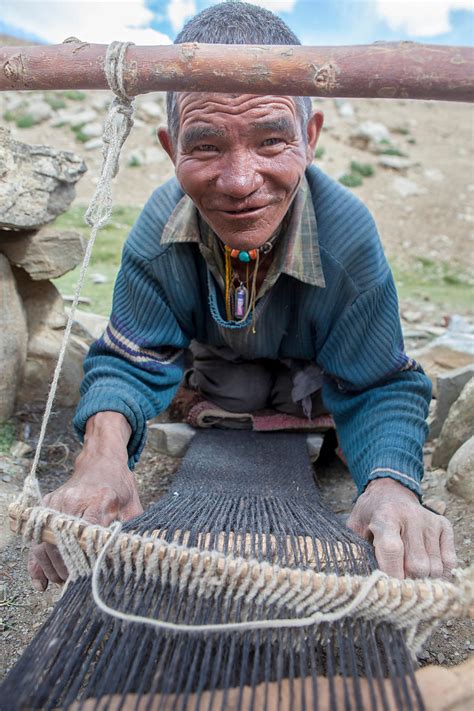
[159,93,322,249]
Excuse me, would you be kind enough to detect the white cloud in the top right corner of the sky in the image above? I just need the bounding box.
[375,0,474,37]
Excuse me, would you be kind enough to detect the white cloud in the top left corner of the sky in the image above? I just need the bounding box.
[2,0,171,44]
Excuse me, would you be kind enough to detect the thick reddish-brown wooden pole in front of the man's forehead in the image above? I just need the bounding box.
[0,40,474,101]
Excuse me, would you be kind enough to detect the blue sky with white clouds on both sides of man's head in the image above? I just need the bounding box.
[0,0,474,46]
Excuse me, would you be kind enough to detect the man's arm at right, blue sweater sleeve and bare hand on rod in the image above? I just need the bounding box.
[319,274,455,577]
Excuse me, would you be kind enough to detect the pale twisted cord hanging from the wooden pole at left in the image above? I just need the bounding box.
[18,42,134,508]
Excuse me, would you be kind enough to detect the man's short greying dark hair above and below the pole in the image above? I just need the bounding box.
[166,0,312,144]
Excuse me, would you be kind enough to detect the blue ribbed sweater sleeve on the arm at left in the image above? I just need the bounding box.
[74,243,189,467]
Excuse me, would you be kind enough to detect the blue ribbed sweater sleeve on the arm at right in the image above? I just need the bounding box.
[318,272,431,495]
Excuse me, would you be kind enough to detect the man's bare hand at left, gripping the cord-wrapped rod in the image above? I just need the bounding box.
[28,412,143,590]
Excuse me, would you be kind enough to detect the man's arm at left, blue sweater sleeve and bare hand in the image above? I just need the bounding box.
[29,236,189,589]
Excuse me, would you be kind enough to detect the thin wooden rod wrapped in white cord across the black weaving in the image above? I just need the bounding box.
[9,504,474,618]
